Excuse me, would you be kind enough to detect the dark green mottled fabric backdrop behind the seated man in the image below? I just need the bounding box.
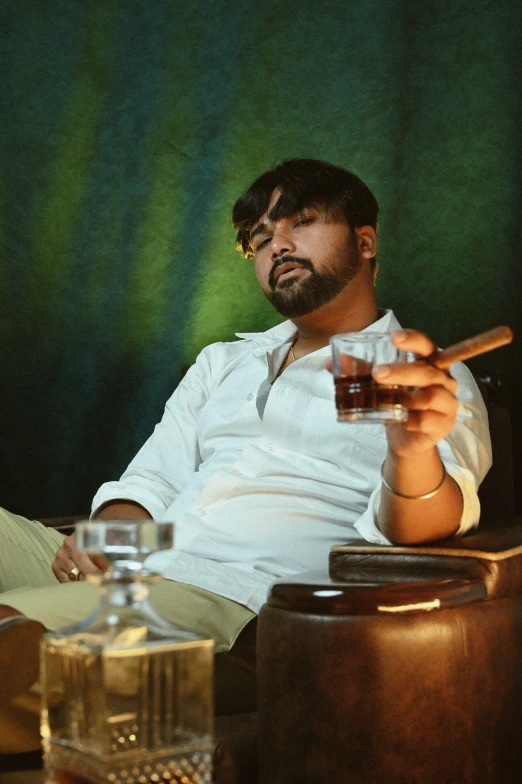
[0,0,522,516]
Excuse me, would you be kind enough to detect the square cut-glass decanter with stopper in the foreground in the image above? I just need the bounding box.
[41,520,214,784]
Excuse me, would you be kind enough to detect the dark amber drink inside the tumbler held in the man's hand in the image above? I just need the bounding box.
[335,374,407,421]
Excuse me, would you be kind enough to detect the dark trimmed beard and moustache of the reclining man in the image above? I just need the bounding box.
[265,237,362,318]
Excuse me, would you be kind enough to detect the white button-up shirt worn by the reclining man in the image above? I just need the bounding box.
[93,311,491,612]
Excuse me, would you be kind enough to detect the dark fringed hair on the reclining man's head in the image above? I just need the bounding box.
[232,158,379,268]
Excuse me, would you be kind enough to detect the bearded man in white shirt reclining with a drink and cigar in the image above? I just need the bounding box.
[0,160,491,752]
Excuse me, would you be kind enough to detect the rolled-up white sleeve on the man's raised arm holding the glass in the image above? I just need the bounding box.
[354,362,491,545]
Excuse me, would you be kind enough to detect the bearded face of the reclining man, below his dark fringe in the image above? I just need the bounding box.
[251,190,362,318]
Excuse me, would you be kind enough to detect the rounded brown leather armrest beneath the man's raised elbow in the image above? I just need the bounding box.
[258,526,522,784]
